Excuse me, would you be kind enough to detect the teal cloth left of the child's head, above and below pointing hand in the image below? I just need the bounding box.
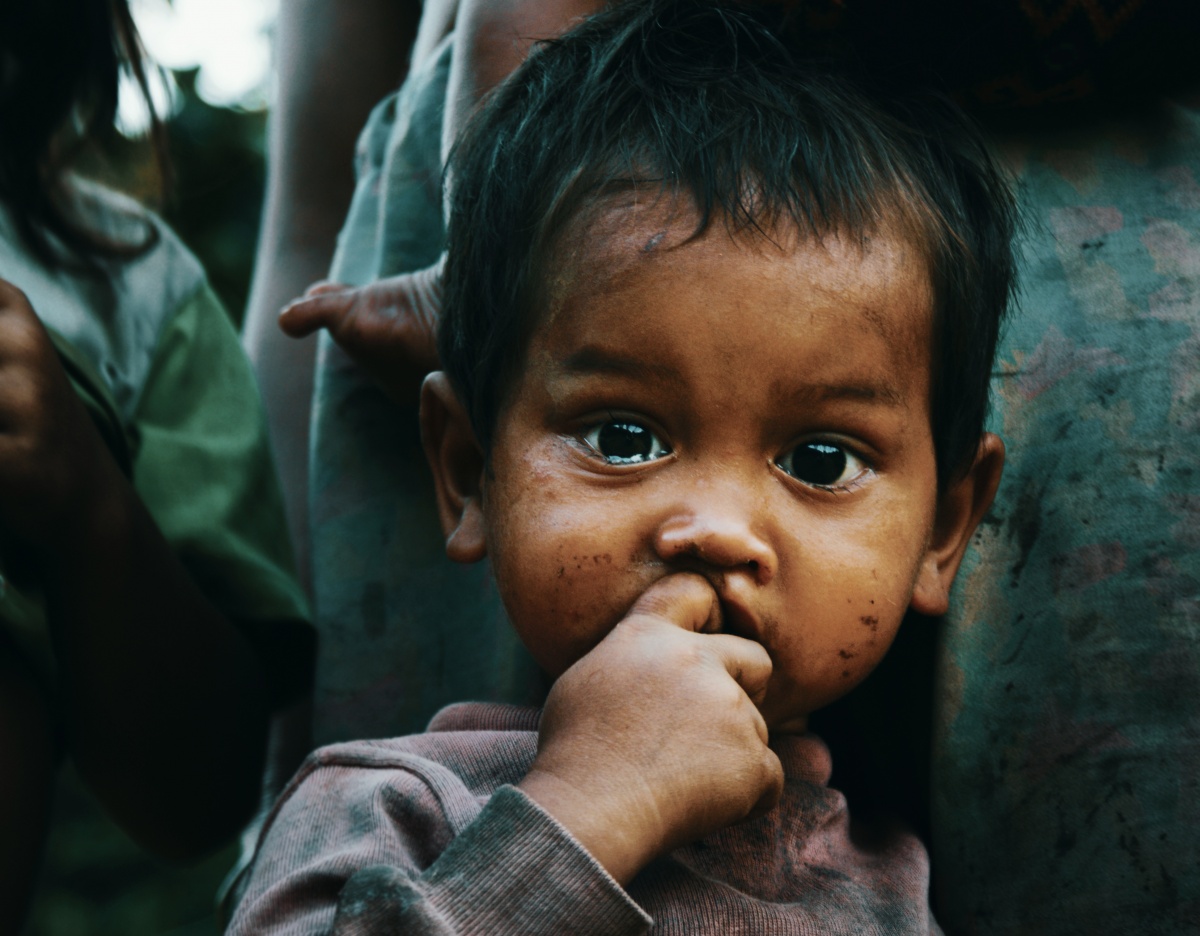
[310,42,539,744]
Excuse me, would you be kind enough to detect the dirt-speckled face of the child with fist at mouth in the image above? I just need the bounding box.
[427,205,998,731]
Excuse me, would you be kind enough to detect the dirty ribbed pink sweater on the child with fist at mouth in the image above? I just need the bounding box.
[229,703,941,936]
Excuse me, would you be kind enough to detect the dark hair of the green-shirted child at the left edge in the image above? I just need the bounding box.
[0,0,169,271]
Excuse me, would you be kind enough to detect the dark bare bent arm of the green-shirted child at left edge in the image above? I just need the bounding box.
[0,282,266,858]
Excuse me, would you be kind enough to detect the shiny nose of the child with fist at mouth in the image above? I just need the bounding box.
[654,499,779,586]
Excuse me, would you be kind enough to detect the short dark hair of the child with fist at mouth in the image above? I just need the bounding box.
[439,0,1015,486]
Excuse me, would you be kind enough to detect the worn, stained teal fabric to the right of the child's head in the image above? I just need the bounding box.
[932,102,1200,936]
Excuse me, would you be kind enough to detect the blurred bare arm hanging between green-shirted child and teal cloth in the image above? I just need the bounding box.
[242,0,432,578]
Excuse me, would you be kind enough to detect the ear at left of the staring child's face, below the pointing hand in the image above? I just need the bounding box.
[421,371,487,563]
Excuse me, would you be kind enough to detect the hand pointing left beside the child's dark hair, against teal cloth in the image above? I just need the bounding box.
[280,260,443,404]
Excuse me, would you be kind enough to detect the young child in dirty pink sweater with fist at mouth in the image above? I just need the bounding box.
[232,0,1013,934]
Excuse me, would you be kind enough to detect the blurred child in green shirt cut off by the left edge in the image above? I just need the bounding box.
[0,0,311,934]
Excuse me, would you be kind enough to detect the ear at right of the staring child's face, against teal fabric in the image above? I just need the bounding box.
[912,432,1004,617]
